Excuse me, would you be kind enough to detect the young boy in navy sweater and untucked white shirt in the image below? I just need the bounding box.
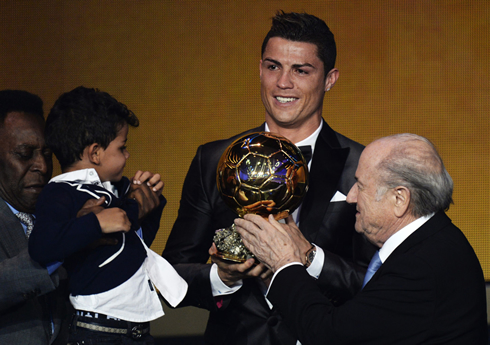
[29,87,187,344]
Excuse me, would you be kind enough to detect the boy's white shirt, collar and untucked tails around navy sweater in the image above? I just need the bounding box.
[49,169,187,322]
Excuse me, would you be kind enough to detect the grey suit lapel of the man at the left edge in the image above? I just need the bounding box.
[0,199,27,257]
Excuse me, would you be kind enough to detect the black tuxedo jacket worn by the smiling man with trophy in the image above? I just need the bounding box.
[163,122,375,345]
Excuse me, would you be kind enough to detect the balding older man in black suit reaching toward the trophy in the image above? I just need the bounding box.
[235,134,488,345]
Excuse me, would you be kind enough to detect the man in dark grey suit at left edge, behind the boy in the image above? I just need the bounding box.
[0,90,71,345]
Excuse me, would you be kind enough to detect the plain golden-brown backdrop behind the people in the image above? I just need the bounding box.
[0,0,490,280]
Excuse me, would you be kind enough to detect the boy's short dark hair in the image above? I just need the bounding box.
[45,86,139,170]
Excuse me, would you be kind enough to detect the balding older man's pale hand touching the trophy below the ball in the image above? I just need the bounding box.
[235,214,304,272]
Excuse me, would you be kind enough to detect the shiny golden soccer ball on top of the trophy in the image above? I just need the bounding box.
[217,132,308,216]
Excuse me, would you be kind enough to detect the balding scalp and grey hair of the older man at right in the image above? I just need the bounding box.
[376,133,453,217]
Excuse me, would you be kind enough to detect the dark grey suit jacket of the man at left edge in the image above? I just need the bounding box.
[0,199,69,345]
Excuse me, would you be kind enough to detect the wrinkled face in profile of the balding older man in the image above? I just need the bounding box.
[347,144,397,248]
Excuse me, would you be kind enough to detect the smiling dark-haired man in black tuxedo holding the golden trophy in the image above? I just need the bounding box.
[163,13,375,345]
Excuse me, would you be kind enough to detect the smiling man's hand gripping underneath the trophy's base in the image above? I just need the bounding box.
[209,243,272,286]
